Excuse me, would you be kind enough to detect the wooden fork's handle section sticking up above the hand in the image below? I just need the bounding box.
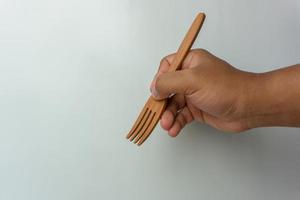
[169,13,205,72]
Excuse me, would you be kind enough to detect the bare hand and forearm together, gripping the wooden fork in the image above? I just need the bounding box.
[150,49,300,137]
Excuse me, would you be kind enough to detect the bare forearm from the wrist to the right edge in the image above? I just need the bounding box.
[247,64,300,128]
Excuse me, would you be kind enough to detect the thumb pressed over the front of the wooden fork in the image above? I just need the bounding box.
[151,69,193,100]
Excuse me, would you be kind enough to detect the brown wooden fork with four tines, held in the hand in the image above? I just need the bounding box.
[126,13,205,146]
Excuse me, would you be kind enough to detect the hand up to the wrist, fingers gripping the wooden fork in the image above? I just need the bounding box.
[150,49,256,137]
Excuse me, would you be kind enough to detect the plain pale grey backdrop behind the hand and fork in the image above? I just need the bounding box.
[0,0,300,200]
